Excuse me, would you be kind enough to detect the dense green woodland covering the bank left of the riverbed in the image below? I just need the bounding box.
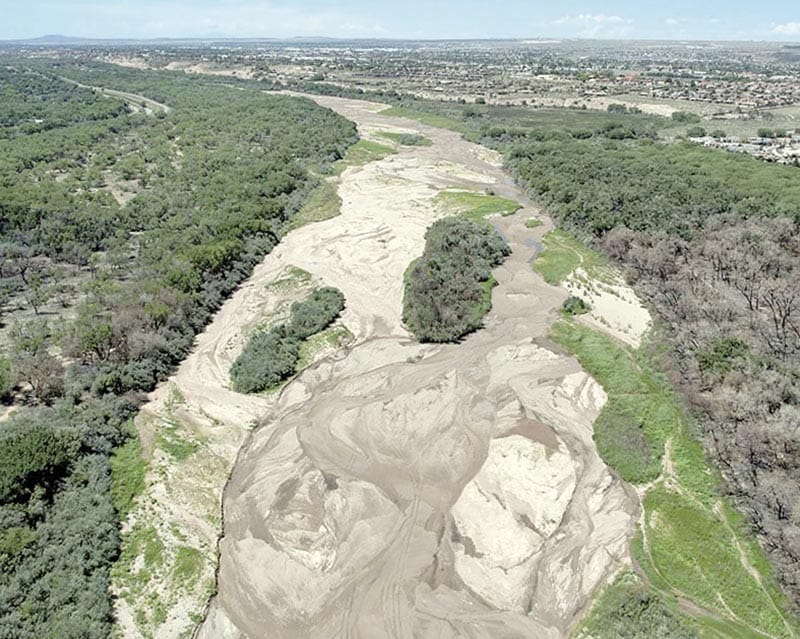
[0,58,356,639]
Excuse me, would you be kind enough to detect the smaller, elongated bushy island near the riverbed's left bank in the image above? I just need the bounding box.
[231,287,344,393]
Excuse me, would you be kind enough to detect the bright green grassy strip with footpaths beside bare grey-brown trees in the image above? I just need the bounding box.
[551,320,800,638]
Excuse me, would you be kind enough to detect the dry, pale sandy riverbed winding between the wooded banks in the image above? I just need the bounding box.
[195,97,637,639]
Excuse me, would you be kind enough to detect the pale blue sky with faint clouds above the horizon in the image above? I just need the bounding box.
[0,0,800,42]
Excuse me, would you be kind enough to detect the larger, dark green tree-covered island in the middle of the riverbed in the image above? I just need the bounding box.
[403,217,510,342]
